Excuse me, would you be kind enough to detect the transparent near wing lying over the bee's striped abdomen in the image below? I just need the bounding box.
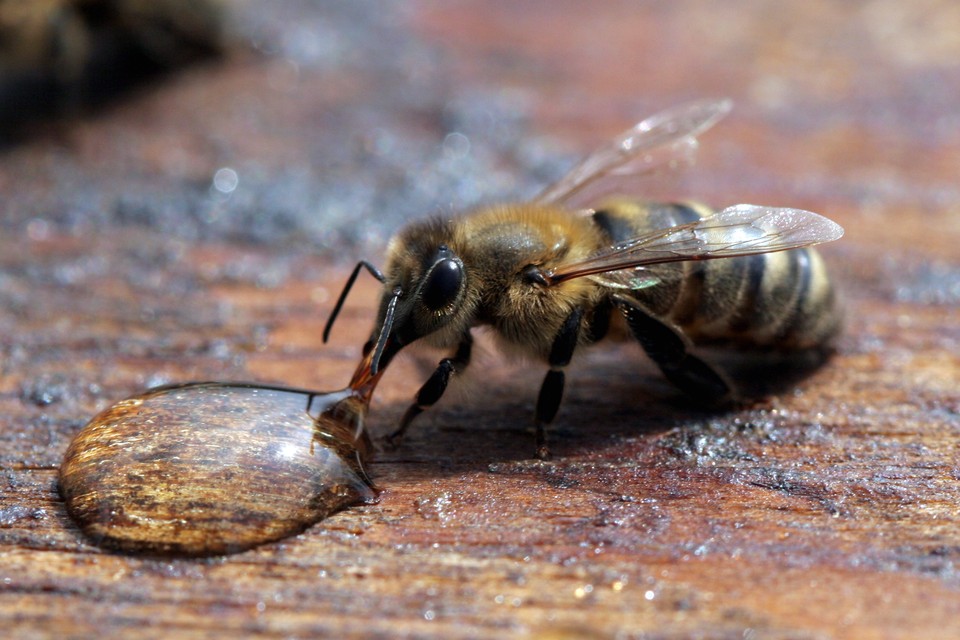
[545,204,843,288]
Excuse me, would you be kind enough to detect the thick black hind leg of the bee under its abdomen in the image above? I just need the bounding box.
[615,298,736,406]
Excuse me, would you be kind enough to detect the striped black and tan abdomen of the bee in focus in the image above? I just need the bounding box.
[594,200,840,349]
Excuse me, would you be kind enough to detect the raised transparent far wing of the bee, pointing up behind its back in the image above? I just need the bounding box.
[533,100,733,210]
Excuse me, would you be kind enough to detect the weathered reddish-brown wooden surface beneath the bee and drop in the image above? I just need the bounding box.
[0,0,960,638]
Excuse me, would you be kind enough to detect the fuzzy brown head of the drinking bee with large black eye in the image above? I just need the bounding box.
[366,220,475,374]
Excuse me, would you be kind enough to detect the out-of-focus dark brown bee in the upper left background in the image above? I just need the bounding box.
[0,0,225,120]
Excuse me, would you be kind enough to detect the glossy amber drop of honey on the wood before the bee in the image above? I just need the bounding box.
[60,382,376,555]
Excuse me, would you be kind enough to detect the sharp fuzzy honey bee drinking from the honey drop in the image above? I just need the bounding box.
[323,100,843,458]
